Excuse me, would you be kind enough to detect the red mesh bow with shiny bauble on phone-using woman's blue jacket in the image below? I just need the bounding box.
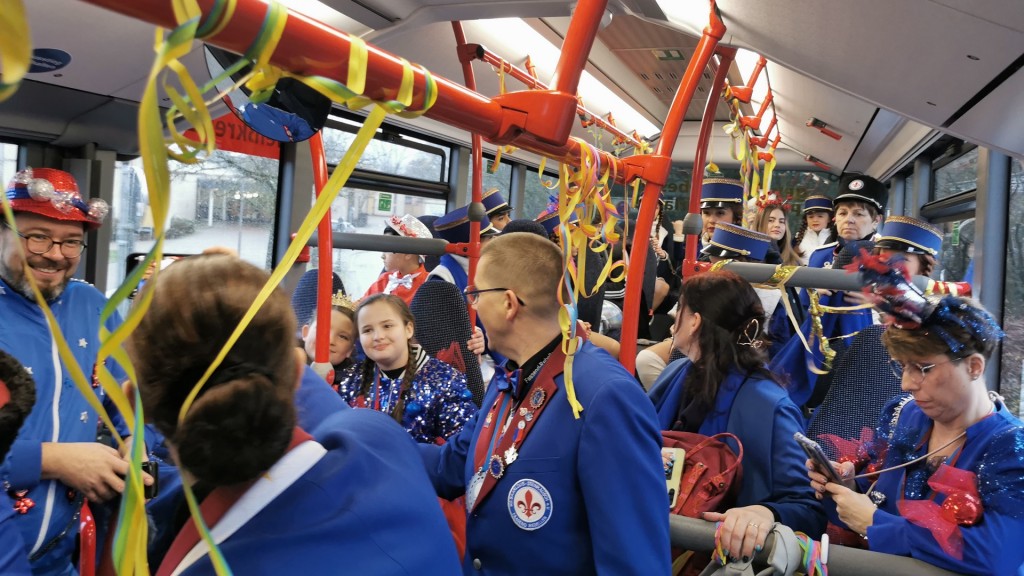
[897,464,984,560]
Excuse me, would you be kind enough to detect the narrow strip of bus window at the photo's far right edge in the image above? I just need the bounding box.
[999,158,1024,415]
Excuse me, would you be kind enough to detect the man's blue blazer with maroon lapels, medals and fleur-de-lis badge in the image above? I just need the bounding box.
[420,338,670,575]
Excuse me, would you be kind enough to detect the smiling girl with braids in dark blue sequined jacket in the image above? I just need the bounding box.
[338,294,476,444]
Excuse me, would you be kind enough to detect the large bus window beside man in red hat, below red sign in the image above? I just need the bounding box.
[108,150,278,287]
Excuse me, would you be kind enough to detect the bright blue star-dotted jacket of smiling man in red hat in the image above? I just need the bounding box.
[0,280,127,575]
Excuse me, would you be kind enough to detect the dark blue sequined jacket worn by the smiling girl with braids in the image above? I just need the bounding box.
[338,345,476,444]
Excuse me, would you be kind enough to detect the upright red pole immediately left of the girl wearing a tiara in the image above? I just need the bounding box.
[307,132,334,363]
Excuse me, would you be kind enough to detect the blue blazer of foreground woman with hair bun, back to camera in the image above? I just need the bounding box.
[177,410,459,576]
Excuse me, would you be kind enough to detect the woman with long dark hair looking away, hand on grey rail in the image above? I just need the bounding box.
[649,271,825,560]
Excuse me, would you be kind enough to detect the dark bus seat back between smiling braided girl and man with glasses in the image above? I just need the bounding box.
[409,282,483,406]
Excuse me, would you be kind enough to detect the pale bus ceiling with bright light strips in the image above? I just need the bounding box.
[9,0,1024,167]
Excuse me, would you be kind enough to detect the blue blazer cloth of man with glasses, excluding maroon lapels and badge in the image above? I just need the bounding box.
[419,342,671,576]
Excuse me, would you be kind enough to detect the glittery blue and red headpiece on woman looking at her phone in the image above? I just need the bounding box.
[847,250,1006,357]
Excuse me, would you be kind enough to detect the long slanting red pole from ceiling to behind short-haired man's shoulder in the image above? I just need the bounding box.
[618,0,725,372]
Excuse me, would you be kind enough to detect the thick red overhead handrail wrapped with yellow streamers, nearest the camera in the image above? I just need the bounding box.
[82,0,635,182]
